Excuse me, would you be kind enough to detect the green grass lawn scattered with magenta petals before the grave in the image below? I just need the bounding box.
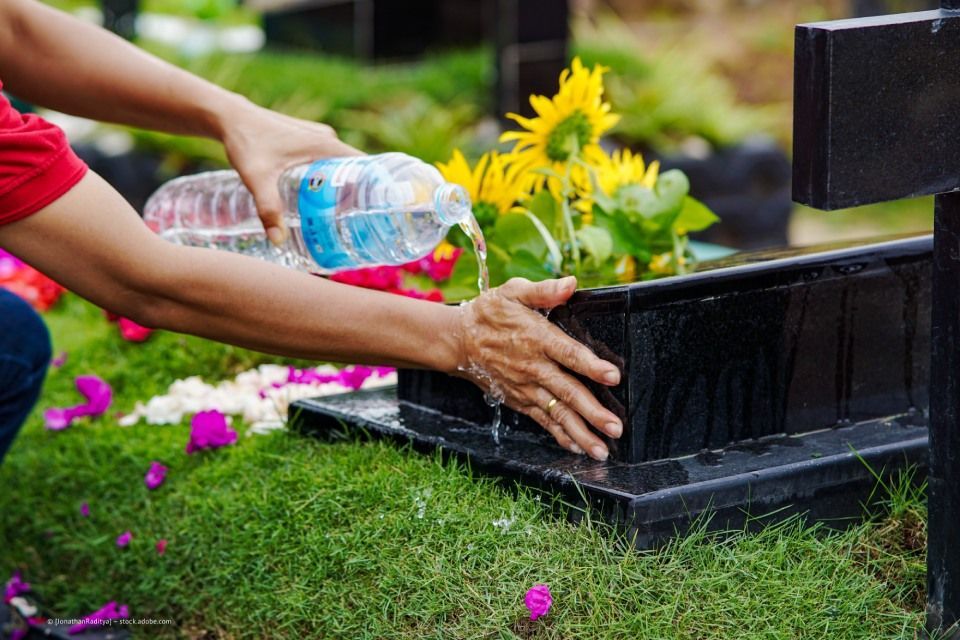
[0,296,924,640]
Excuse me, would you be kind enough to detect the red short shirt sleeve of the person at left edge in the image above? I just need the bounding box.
[0,82,87,225]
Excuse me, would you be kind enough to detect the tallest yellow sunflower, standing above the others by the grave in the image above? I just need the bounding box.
[500,58,619,188]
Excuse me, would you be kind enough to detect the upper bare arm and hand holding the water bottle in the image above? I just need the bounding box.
[0,0,359,244]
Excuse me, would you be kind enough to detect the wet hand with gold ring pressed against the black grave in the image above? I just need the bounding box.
[458,277,623,460]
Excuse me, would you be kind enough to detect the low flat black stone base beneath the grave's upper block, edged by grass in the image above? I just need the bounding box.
[290,388,927,548]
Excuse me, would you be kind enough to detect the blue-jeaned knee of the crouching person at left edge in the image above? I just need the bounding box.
[0,289,50,462]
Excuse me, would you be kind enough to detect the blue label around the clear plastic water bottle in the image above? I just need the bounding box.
[297,160,355,271]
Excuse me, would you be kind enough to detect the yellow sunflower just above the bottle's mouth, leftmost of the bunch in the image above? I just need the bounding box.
[437,149,521,226]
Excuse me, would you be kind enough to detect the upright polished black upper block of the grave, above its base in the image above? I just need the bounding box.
[398,236,932,463]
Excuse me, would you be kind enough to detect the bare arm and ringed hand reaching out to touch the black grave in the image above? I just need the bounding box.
[0,172,621,458]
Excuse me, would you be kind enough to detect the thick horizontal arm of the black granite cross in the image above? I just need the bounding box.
[793,9,960,209]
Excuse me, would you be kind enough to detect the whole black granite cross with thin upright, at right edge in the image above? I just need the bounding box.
[793,0,960,637]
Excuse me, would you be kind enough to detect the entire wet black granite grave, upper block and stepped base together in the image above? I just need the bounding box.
[292,236,932,547]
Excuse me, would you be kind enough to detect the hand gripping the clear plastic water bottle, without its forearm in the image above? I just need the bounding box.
[223,105,362,245]
